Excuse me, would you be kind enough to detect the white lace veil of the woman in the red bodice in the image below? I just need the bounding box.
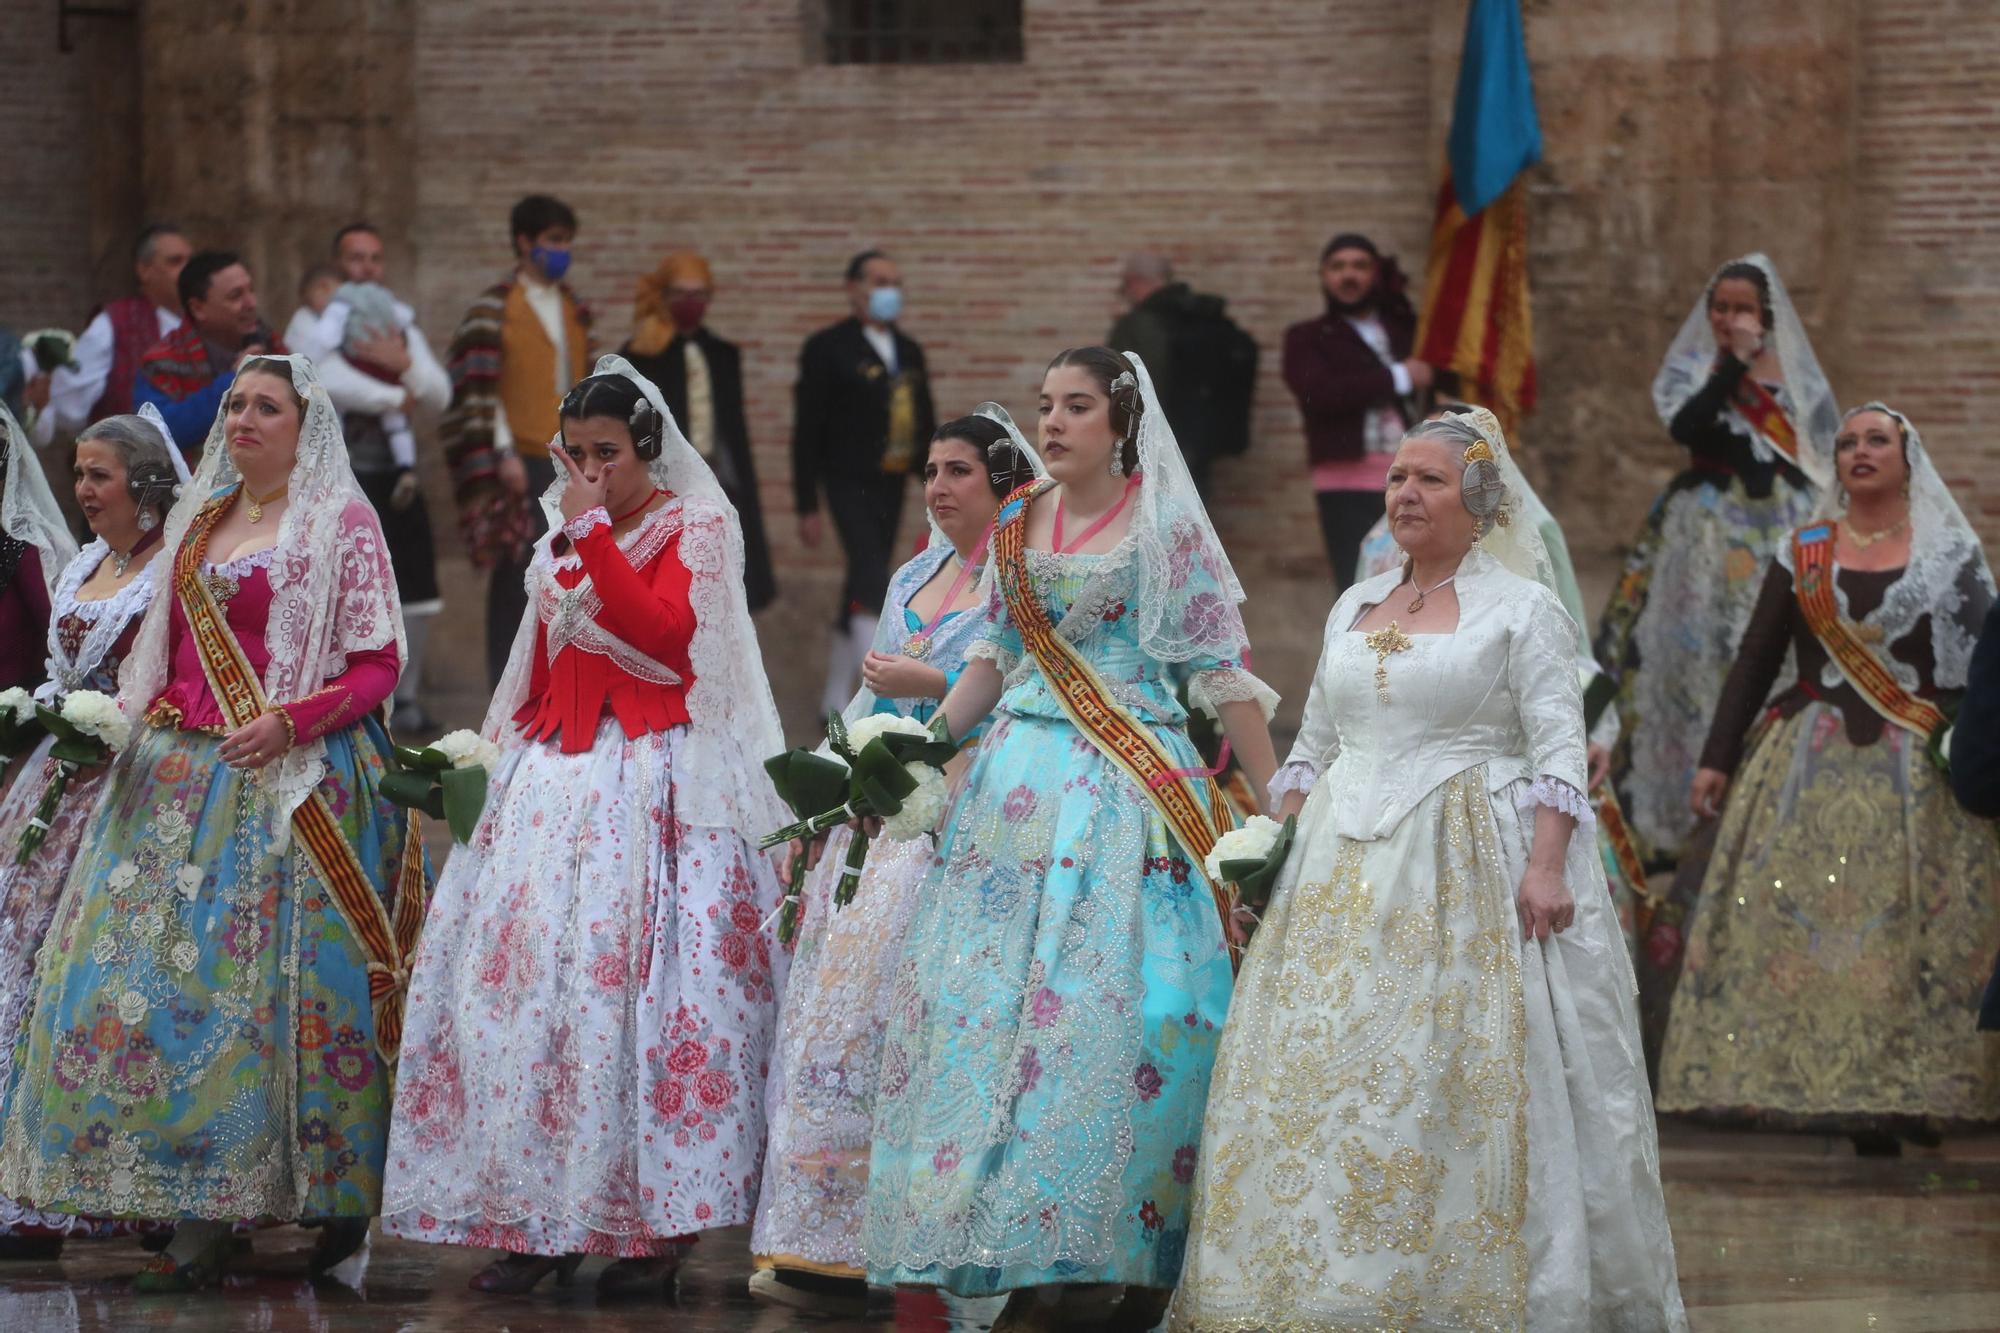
[482,356,790,833]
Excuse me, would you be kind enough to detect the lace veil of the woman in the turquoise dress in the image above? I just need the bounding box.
[1122,352,1250,662]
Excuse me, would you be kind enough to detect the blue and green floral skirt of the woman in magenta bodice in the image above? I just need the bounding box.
[0,721,406,1221]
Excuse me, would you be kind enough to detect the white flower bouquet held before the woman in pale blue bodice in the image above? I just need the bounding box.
[758,713,958,932]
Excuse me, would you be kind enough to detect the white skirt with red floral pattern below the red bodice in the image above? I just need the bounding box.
[382,719,782,1257]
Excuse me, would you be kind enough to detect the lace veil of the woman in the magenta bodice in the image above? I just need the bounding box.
[118,356,410,843]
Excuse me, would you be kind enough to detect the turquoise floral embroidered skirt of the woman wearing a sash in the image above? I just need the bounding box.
[864,713,1230,1295]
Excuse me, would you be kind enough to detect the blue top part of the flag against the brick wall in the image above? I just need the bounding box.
[1446,0,1542,218]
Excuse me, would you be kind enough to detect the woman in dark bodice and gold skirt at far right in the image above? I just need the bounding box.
[1660,402,2000,1153]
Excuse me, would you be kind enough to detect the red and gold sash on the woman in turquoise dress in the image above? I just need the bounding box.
[994,480,1240,967]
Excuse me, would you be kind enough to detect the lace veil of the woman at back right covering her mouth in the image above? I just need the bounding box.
[1652,252,1840,490]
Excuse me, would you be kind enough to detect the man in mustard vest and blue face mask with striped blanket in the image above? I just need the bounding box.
[438,194,592,685]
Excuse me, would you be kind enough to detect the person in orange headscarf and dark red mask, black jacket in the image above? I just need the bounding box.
[622,250,778,610]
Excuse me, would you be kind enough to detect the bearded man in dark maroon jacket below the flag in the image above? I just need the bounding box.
[1284,232,1432,596]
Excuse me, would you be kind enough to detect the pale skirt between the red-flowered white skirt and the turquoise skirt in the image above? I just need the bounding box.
[750,829,932,1277]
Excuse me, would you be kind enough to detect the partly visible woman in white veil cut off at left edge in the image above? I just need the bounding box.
[0,404,76,691]
